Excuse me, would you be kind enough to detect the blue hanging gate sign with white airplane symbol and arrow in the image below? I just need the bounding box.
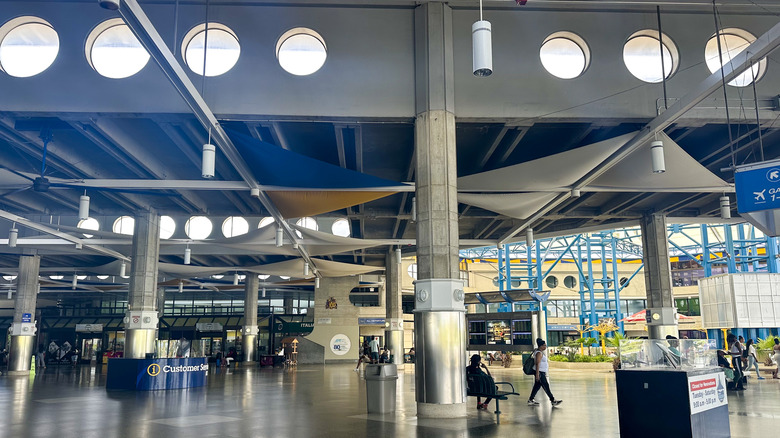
[734,160,780,213]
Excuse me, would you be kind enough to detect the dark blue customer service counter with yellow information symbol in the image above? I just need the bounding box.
[106,357,209,391]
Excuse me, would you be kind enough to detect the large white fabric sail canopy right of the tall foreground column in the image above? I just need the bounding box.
[458,132,733,219]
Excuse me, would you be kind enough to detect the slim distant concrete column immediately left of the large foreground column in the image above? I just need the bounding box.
[385,249,404,365]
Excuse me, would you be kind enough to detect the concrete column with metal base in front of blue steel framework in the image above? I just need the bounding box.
[641,213,678,339]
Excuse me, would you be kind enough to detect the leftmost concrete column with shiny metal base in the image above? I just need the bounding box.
[8,255,41,376]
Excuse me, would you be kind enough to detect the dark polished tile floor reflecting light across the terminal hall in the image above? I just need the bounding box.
[0,365,780,438]
